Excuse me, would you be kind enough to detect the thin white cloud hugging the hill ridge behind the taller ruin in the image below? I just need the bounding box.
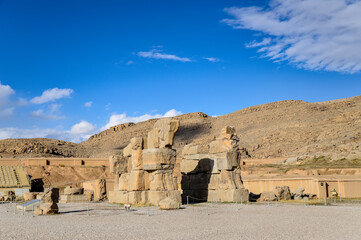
[100,109,182,131]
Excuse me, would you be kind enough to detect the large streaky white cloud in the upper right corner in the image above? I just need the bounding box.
[223,0,361,73]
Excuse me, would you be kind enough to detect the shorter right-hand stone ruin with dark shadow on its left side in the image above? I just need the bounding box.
[180,126,248,202]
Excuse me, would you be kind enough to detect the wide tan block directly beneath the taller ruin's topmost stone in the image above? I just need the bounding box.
[143,148,176,170]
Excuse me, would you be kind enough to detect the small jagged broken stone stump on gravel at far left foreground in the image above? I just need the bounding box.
[34,188,59,215]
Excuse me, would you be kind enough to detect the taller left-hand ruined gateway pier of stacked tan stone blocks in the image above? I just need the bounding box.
[109,119,181,209]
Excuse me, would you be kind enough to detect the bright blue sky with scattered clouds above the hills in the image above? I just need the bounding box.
[0,0,361,142]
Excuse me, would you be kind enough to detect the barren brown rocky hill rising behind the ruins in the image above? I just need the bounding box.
[0,96,361,159]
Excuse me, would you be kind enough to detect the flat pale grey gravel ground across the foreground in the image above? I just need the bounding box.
[0,203,361,240]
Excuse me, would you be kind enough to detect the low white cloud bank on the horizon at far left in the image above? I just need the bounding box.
[0,121,97,143]
